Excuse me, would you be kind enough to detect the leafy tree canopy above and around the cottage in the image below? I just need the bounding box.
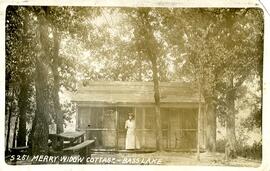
[6,6,263,156]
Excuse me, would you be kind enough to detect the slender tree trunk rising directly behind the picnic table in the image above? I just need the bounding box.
[52,29,64,134]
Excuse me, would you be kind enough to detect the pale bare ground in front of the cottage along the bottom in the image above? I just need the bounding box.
[7,152,261,167]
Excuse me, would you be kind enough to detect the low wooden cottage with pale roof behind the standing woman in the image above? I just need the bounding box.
[72,82,205,151]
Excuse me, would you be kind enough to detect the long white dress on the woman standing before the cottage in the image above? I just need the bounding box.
[125,120,140,150]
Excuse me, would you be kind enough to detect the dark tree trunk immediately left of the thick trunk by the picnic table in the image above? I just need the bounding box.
[17,77,29,147]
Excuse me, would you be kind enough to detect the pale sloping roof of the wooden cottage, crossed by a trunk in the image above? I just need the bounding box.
[72,81,203,104]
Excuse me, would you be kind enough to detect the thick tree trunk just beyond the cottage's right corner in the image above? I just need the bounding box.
[206,98,217,152]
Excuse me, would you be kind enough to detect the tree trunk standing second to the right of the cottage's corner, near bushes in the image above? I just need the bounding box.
[225,76,237,159]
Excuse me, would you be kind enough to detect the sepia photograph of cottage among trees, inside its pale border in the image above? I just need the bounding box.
[4,2,265,168]
